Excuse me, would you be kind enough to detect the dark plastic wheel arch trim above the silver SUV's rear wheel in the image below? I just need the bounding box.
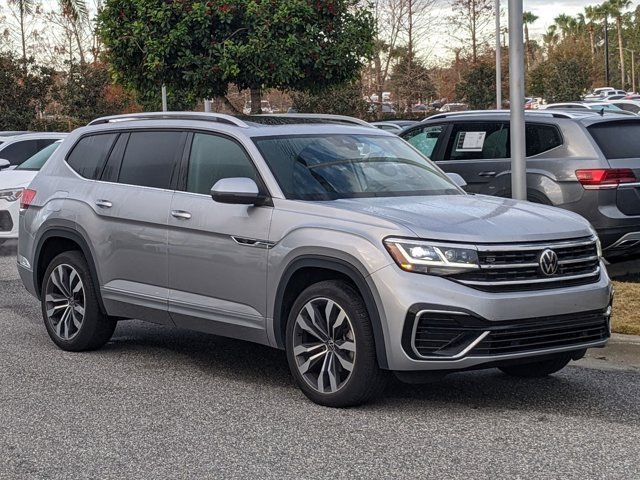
[33,226,106,314]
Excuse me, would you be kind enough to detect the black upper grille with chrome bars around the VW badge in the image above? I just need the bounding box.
[450,237,600,292]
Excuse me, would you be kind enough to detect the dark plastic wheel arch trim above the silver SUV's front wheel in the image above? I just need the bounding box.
[273,255,388,369]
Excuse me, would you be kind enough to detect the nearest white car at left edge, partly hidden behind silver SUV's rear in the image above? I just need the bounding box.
[0,140,61,245]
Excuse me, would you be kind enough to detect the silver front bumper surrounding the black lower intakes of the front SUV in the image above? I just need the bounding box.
[371,265,613,371]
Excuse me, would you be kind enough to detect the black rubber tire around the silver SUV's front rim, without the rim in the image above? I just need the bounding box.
[286,280,389,408]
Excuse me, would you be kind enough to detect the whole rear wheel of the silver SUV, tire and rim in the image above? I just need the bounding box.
[41,251,117,352]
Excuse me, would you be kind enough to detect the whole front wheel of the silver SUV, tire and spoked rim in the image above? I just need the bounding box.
[286,280,387,407]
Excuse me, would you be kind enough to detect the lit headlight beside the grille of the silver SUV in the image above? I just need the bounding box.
[384,238,480,275]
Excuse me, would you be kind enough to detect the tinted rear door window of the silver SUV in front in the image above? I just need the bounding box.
[118,131,184,188]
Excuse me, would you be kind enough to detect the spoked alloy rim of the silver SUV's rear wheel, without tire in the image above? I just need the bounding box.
[45,264,85,340]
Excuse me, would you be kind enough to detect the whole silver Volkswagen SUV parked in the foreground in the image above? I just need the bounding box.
[18,113,612,406]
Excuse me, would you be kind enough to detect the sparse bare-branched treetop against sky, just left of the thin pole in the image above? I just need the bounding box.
[449,0,494,64]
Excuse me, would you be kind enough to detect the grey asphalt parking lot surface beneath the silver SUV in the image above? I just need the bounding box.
[0,240,640,479]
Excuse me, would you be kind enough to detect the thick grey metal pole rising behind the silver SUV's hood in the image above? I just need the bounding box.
[509,0,527,200]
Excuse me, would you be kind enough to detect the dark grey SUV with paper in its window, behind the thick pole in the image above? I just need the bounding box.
[401,110,640,260]
